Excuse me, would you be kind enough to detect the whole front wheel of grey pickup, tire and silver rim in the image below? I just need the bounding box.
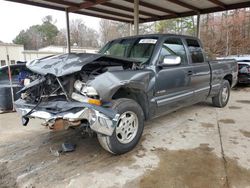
[97,98,144,154]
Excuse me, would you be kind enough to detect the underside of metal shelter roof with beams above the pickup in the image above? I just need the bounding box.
[5,0,250,23]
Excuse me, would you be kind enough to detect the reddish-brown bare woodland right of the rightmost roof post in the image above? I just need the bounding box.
[201,8,250,57]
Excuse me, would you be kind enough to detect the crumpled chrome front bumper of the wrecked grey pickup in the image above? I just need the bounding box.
[15,99,120,136]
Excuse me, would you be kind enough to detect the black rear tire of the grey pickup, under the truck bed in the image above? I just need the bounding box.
[212,80,231,108]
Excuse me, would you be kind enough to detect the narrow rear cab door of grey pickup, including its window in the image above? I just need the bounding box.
[185,38,211,102]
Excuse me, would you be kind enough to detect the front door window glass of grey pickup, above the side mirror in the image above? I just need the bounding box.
[160,38,187,64]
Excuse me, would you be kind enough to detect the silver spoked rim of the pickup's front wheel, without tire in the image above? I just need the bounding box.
[116,111,139,144]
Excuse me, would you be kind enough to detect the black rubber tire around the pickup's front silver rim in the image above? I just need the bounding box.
[97,98,144,155]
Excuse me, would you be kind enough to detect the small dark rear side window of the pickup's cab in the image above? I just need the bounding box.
[186,39,205,63]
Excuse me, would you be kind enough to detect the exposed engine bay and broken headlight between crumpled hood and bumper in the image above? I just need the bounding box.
[21,62,132,103]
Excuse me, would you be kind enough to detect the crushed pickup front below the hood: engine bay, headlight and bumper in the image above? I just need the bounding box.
[12,53,132,136]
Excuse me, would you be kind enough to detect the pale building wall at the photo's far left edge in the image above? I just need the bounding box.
[0,43,24,67]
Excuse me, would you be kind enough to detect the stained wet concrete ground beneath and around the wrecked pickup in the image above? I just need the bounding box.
[0,87,250,188]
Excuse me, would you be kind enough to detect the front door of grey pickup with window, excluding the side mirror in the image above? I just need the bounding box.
[154,37,194,115]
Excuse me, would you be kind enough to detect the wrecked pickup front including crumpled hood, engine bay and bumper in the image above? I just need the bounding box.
[15,54,141,135]
